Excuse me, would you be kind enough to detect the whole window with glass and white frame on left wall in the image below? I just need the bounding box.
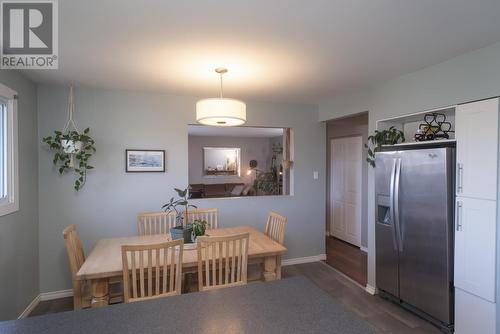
[0,84,19,216]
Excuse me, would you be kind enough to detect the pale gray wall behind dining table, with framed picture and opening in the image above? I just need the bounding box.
[38,85,326,292]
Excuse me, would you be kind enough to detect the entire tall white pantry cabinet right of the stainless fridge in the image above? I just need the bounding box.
[454,98,499,334]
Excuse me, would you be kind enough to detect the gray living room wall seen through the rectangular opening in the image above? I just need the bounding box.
[189,136,273,184]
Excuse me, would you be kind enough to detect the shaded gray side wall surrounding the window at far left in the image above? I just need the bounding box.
[0,70,39,320]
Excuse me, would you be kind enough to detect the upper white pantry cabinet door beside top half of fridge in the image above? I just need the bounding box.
[455,98,498,200]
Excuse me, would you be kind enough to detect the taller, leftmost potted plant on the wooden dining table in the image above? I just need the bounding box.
[161,187,196,243]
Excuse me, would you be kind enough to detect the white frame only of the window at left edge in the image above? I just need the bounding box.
[0,84,19,216]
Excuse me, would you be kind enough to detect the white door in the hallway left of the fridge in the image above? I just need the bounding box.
[329,136,363,247]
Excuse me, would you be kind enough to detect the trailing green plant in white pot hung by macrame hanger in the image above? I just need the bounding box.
[42,86,95,191]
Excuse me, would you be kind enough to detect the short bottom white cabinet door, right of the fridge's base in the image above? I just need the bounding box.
[455,289,496,334]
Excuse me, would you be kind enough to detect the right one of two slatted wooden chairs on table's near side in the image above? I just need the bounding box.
[197,233,250,291]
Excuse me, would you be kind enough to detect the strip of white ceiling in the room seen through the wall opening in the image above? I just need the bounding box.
[188,125,283,138]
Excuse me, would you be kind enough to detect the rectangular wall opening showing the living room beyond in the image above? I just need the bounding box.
[188,125,293,198]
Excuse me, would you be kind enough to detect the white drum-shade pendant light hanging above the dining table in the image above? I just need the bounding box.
[196,67,247,126]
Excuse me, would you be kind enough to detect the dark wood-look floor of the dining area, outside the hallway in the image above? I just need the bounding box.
[30,262,441,334]
